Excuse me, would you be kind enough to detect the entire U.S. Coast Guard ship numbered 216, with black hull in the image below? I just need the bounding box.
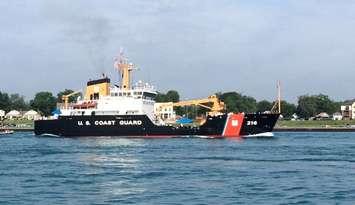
[34,53,279,137]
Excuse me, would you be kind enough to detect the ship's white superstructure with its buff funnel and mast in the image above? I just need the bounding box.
[60,51,157,121]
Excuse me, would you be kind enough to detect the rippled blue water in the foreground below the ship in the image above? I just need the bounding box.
[0,133,355,205]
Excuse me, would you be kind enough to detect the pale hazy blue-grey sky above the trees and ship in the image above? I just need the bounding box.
[0,0,355,102]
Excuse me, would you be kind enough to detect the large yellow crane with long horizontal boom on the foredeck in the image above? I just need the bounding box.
[169,95,225,116]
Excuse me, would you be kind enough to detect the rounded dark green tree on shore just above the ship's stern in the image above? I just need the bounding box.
[30,92,57,116]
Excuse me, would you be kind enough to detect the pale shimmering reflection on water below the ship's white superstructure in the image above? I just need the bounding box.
[80,137,145,200]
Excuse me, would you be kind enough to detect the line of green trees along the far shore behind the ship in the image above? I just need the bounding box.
[0,89,344,119]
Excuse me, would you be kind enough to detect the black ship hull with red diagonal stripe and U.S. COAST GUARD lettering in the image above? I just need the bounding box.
[35,113,279,137]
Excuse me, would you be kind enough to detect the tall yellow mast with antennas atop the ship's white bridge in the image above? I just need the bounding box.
[115,50,137,90]
